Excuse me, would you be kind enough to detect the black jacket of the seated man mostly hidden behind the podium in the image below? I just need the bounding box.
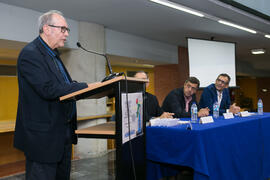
[145,92,164,121]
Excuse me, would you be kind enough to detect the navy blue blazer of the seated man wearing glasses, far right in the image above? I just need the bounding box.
[200,84,231,115]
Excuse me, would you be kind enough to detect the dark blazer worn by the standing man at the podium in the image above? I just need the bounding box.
[14,38,87,162]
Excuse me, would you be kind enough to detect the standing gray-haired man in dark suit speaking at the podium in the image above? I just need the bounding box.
[14,11,88,180]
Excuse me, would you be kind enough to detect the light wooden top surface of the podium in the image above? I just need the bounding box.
[60,76,149,101]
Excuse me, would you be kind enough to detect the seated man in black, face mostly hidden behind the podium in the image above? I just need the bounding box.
[134,71,173,121]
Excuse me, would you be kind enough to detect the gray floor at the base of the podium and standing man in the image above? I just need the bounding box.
[0,151,115,180]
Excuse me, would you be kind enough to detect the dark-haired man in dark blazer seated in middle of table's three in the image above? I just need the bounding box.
[162,77,209,118]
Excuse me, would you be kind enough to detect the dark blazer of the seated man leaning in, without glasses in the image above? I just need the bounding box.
[162,88,199,118]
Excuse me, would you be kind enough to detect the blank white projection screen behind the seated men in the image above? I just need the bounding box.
[188,38,236,87]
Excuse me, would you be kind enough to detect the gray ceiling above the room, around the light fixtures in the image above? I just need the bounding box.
[0,0,270,73]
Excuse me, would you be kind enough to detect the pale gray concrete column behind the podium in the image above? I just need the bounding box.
[62,22,107,159]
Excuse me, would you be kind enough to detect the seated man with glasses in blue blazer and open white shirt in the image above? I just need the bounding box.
[200,73,240,115]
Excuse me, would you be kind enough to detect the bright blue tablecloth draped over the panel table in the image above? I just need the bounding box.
[146,113,270,180]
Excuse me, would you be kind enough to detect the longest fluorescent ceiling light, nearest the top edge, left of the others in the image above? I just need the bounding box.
[150,0,204,17]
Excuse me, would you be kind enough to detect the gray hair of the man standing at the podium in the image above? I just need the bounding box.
[38,10,64,34]
